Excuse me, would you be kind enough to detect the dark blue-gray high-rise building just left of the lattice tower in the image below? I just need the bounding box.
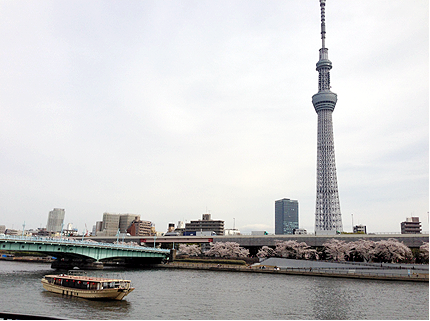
[275,198,299,234]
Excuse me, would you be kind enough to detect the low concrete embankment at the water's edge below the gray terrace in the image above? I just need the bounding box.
[156,262,429,282]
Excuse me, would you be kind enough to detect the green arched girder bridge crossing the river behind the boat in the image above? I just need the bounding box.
[0,235,170,269]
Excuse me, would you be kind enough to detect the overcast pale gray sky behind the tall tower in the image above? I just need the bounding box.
[0,0,429,232]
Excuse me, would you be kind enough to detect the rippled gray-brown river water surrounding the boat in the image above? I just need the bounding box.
[0,261,429,320]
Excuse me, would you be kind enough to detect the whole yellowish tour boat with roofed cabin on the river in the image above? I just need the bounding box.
[42,271,134,300]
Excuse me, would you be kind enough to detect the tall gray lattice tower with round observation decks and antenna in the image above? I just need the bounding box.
[312,0,343,235]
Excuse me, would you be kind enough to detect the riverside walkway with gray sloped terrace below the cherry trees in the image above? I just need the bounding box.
[157,258,429,282]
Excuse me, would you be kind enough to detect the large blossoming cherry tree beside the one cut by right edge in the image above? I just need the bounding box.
[371,238,412,263]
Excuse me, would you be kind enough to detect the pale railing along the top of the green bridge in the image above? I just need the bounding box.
[0,235,170,253]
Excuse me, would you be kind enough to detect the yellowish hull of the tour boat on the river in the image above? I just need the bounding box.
[42,279,134,300]
